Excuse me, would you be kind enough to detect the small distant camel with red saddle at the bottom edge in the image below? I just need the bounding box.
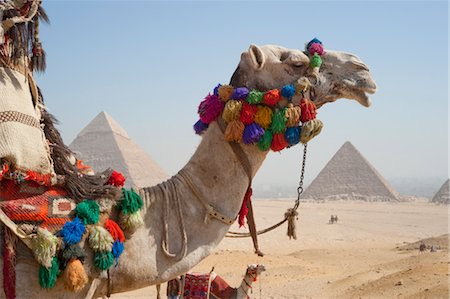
[184,264,266,299]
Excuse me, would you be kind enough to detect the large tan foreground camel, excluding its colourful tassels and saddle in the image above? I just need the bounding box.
[0,3,376,298]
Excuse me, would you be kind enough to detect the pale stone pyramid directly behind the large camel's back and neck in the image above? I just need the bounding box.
[69,112,168,188]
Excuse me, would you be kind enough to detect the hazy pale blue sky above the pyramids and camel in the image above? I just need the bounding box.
[38,1,449,188]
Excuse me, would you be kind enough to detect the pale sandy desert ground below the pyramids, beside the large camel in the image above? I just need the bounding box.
[112,201,450,299]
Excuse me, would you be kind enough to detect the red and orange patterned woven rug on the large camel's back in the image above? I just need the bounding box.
[0,180,76,233]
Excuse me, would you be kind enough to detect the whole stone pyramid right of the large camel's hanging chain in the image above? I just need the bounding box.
[302,141,399,201]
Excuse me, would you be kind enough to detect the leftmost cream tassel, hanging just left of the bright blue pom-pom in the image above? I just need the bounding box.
[32,228,58,268]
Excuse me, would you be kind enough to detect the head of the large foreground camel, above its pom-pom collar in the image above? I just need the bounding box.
[230,45,376,107]
